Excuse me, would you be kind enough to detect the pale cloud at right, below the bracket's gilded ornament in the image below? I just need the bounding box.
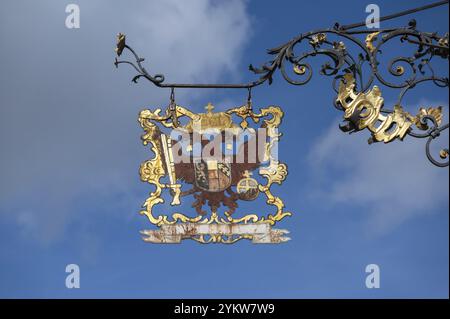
[308,109,449,235]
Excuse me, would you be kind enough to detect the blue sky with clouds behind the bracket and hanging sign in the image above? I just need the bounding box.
[0,0,449,298]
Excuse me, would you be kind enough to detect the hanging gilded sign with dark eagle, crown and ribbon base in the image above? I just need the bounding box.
[139,99,291,244]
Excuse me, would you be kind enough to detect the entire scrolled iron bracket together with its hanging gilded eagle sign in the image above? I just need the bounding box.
[115,0,449,244]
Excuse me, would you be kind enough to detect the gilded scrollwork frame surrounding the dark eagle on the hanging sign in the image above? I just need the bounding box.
[138,105,292,242]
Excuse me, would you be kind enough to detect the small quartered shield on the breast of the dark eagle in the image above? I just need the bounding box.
[194,159,231,192]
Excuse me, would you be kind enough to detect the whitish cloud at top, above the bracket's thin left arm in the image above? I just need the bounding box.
[134,0,251,83]
